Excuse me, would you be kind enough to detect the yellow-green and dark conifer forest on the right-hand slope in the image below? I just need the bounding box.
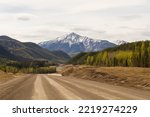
[69,41,150,67]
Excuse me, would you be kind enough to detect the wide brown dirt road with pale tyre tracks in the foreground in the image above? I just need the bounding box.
[0,75,150,100]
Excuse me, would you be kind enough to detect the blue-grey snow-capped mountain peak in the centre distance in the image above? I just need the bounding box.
[39,33,116,54]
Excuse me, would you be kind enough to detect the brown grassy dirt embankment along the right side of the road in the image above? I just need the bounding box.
[62,66,150,90]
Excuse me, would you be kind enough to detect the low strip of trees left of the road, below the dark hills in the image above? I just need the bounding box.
[0,58,56,74]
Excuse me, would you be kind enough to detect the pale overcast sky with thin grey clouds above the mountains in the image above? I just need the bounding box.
[0,0,150,43]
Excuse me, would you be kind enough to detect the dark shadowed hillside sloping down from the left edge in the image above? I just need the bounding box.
[0,36,70,63]
